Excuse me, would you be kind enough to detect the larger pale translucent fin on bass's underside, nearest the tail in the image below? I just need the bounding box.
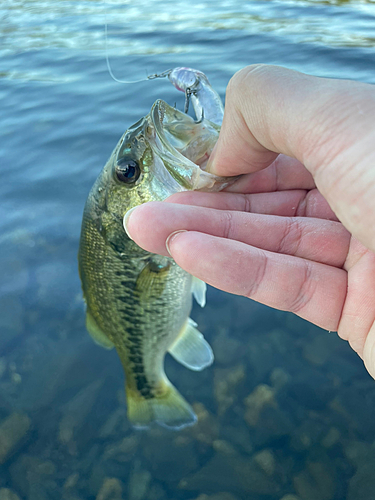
[168,318,214,371]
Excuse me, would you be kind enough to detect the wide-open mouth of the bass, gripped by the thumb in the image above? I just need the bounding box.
[149,99,236,191]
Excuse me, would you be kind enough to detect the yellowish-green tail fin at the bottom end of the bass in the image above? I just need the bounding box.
[126,382,197,429]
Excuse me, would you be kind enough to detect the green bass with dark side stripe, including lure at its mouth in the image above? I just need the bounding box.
[78,68,231,429]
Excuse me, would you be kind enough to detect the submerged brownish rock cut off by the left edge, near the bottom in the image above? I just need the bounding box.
[0,413,31,464]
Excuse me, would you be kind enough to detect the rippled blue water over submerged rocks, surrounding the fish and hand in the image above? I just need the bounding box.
[0,0,375,500]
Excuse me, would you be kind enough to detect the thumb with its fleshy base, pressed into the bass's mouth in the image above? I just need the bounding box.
[208,65,375,250]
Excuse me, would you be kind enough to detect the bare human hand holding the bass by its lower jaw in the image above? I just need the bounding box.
[127,65,375,377]
